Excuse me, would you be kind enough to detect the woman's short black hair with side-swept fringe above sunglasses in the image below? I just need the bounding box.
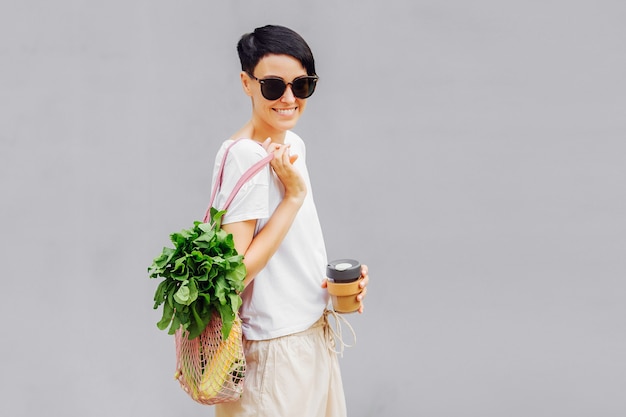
[237,25,316,75]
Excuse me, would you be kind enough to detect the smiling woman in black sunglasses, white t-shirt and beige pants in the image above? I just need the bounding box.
[214,26,369,417]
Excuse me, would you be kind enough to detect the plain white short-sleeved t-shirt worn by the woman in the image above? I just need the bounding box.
[213,131,328,340]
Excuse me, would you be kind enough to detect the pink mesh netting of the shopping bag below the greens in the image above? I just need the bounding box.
[175,314,246,405]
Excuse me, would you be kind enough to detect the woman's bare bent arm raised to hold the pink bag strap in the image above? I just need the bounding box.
[222,144,307,286]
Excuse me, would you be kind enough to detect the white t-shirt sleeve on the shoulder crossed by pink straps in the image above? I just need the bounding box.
[213,140,270,224]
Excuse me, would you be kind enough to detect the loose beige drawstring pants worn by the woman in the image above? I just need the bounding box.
[215,316,346,417]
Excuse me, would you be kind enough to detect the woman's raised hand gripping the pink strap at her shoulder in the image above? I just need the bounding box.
[263,138,307,204]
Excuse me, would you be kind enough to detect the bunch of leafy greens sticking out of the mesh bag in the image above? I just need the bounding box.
[148,208,246,339]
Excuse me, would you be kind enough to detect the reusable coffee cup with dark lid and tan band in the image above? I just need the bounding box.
[326,259,362,313]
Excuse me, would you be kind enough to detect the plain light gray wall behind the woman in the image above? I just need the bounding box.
[0,0,626,417]
